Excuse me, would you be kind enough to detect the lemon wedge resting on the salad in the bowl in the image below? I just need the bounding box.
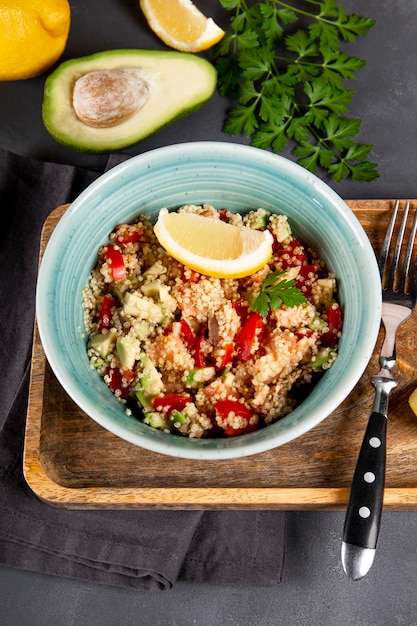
[154,209,273,278]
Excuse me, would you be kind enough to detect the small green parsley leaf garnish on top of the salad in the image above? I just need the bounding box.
[251,270,307,317]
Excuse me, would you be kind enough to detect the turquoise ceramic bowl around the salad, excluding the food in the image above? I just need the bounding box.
[36,142,381,459]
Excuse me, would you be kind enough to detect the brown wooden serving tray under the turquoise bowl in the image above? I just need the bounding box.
[24,200,417,510]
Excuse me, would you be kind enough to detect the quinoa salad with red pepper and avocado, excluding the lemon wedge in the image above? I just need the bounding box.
[82,204,342,438]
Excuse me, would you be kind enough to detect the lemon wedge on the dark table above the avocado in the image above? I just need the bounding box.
[140,0,225,52]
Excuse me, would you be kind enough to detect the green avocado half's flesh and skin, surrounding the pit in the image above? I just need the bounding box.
[42,50,217,154]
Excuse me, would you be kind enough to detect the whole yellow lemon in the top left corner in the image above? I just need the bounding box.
[0,0,71,81]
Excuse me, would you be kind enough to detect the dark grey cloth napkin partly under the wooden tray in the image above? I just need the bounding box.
[0,149,285,590]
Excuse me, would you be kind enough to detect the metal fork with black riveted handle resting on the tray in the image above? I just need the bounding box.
[341,200,417,580]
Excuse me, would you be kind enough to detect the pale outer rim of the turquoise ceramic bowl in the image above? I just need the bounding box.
[36,141,381,460]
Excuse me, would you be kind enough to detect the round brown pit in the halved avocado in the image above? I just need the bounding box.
[72,68,150,128]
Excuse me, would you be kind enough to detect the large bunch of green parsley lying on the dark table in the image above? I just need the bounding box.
[214,0,379,181]
